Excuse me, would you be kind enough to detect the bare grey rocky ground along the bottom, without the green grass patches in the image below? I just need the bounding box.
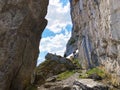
[34,70,120,90]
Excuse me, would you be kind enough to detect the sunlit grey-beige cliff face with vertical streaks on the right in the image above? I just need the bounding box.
[66,0,120,75]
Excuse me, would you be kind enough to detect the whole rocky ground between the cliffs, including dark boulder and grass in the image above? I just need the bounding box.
[31,53,120,90]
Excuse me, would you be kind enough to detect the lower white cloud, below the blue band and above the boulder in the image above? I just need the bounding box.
[40,30,71,56]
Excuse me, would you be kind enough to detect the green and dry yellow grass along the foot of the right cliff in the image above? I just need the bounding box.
[79,66,120,90]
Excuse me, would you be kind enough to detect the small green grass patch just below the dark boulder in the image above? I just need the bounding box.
[57,70,75,80]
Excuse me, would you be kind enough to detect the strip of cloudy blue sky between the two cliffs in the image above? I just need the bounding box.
[37,0,72,65]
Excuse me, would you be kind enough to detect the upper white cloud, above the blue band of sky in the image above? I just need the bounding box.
[46,0,71,33]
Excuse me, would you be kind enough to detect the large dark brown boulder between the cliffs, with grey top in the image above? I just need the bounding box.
[34,53,74,85]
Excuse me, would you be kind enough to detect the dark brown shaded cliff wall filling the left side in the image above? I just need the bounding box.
[0,0,48,90]
